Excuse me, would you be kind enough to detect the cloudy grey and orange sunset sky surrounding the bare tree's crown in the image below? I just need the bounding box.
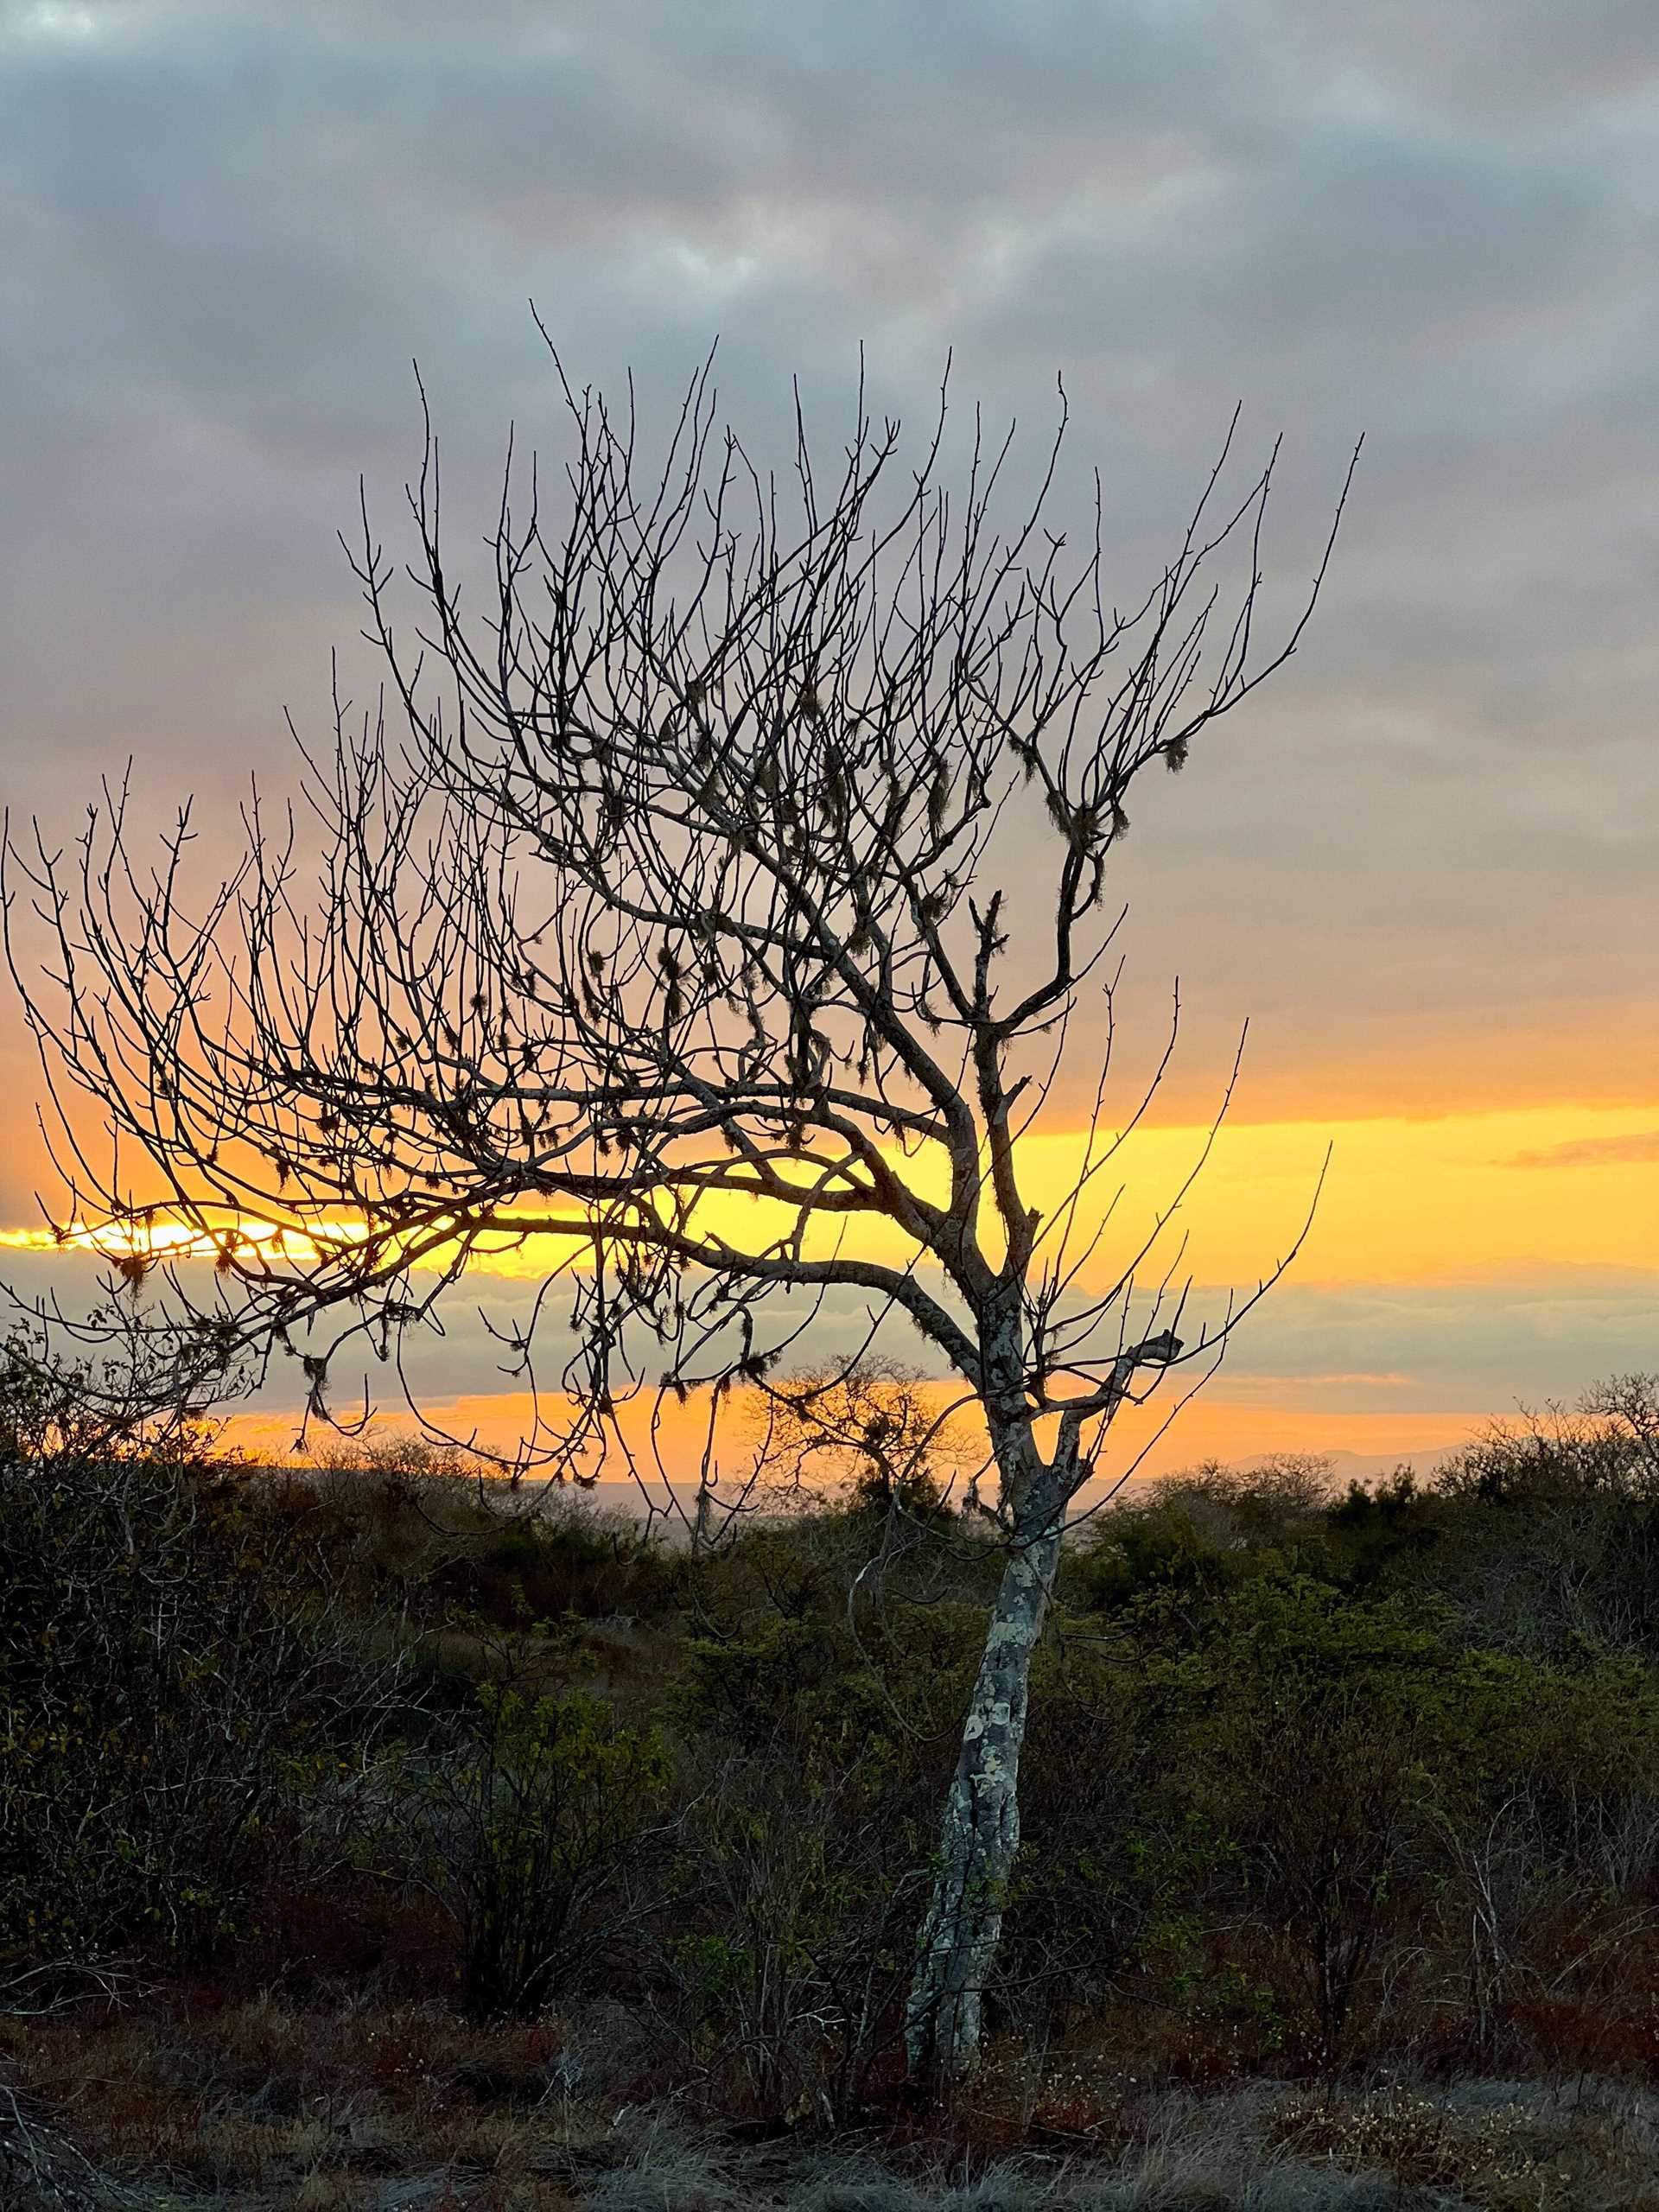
[0,0,1659,1465]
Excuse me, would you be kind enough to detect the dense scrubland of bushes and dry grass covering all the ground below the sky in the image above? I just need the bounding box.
[0,1358,1659,2212]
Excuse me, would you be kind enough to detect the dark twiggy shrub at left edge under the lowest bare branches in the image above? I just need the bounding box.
[0,1344,398,1960]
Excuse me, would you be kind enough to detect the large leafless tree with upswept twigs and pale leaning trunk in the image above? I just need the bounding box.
[9,347,1351,2084]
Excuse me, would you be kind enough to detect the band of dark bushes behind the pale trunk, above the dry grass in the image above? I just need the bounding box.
[0,1358,1659,2126]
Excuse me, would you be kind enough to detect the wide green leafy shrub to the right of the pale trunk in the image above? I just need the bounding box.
[1096,1575,1659,2059]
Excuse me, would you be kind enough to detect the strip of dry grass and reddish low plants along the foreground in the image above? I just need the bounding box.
[0,1988,1659,2212]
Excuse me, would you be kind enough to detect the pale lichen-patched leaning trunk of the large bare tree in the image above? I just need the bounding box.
[905,1510,1062,2093]
